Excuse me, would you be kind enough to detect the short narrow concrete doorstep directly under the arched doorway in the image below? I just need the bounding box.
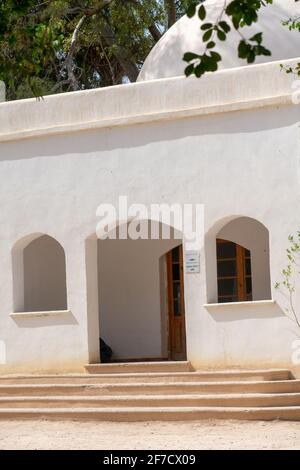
[85,361,193,374]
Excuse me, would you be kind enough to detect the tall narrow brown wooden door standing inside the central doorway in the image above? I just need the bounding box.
[167,245,186,361]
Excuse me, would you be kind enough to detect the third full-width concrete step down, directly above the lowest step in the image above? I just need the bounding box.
[0,393,300,410]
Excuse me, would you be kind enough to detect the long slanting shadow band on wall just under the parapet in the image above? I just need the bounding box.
[0,106,299,161]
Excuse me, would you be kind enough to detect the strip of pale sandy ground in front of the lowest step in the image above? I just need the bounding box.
[0,420,300,450]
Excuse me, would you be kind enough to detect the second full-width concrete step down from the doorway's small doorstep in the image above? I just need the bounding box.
[0,380,300,397]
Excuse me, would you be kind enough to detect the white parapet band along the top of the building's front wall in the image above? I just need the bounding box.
[0,59,299,142]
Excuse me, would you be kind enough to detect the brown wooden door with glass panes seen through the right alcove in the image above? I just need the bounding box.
[217,239,253,303]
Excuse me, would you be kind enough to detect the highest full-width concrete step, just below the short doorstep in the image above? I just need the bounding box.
[0,369,293,385]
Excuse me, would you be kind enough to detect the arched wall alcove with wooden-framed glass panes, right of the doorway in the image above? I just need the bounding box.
[206,217,271,303]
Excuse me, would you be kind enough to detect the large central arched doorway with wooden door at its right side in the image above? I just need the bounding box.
[96,224,186,362]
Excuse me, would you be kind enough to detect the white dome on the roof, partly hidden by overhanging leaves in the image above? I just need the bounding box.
[138,0,300,81]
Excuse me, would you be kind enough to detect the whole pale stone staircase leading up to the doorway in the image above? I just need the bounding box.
[0,362,300,421]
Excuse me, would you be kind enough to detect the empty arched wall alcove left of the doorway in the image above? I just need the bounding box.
[12,233,67,312]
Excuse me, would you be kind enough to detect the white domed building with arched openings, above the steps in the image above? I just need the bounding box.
[0,0,300,372]
